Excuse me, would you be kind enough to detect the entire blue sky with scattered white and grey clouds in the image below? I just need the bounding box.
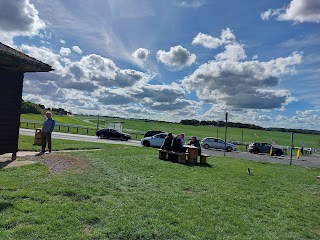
[0,0,320,130]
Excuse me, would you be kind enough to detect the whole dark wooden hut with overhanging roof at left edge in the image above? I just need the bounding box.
[0,43,53,160]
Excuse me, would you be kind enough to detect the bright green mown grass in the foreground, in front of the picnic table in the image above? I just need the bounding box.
[0,140,320,239]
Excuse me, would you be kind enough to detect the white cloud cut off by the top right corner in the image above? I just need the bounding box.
[261,0,320,23]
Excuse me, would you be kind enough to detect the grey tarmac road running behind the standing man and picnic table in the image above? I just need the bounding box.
[20,128,320,168]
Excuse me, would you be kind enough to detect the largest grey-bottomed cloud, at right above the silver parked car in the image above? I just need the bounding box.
[182,52,302,109]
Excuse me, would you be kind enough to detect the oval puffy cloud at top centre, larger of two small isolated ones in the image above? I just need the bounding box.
[157,45,196,69]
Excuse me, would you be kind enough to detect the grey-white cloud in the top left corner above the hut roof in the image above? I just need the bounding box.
[0,0,46,45]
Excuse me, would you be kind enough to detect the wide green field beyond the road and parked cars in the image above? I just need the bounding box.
[21,114,320,148]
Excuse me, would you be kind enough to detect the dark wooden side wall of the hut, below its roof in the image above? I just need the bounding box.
[0,68,23,154]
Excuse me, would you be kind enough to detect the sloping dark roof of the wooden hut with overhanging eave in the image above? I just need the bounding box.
[0,42,53,72]
